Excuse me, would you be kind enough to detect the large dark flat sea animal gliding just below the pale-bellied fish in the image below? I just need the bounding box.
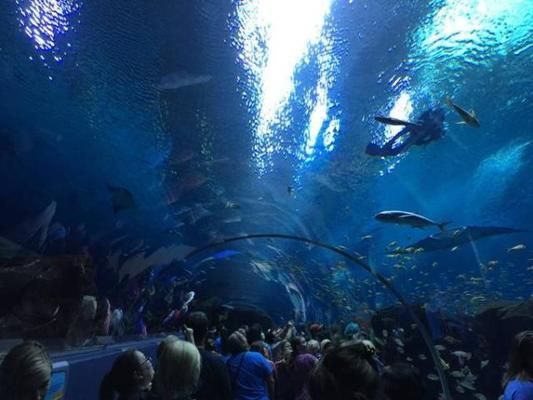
[408,226,527,251]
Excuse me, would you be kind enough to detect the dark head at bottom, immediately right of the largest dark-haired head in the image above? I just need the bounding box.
[381,362,424,400]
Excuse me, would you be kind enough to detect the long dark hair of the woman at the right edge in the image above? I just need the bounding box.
[503,331,533,388]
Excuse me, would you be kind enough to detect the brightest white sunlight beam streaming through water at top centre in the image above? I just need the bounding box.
[235,0,336,171]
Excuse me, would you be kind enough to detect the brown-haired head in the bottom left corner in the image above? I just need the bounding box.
[0,341,52,400]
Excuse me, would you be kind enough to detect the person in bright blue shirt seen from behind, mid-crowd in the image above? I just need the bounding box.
[226,331,274,400]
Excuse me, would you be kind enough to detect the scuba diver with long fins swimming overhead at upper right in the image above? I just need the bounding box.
[366,108,444,157]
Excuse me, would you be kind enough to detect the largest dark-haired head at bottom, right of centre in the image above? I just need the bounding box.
[309,343,379,400]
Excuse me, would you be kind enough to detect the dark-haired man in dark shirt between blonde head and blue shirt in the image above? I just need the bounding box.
[186,312,232,400]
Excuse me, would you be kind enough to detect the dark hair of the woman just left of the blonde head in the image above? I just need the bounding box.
[100,350,140,400]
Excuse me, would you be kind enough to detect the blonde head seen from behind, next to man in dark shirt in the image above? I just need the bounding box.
[155,340,201,400]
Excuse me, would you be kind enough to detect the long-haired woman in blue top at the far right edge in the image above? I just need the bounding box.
[503,331,533,400]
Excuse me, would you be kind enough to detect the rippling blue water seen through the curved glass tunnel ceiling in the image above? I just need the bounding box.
[0,0,533,318]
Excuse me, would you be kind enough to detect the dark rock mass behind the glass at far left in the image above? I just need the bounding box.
[0,256,96,338]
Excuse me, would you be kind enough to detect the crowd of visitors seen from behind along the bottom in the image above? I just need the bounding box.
[0,318,533,400]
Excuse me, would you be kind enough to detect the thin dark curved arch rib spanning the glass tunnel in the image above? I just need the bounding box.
[184,233,452,400]
